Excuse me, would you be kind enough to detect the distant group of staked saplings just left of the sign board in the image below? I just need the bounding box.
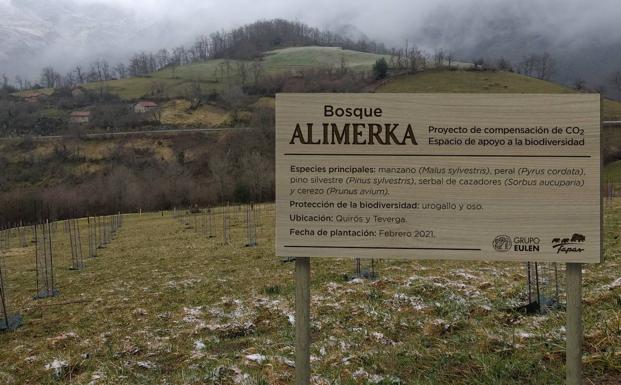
[172,204,270,247]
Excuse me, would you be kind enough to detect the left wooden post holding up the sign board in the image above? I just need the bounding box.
[295,257,310,385]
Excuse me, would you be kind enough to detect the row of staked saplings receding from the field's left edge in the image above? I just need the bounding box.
[0,213,123,330]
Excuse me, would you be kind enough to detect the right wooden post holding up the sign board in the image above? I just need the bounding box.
[566,263,582,385]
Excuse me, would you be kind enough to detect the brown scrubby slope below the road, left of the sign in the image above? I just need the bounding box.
[0,129,274,227]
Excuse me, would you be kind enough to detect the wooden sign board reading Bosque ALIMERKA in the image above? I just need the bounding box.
[276,94,602,263]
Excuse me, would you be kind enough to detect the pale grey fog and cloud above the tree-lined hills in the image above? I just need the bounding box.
[0,0,621,91]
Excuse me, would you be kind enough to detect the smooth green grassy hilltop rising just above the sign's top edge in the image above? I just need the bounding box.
[376,71,621,120]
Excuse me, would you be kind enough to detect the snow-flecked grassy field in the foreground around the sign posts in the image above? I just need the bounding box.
[0,202,621,385]
